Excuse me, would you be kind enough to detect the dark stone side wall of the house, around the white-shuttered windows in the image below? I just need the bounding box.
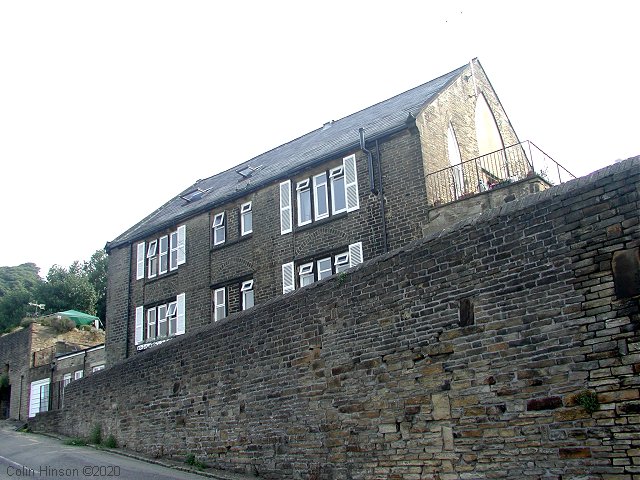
[106,124,444,365]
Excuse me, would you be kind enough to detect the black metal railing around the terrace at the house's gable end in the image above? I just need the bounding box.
[427,140,576,206]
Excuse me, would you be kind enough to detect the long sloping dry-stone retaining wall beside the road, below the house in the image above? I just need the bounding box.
[33,157,640,479]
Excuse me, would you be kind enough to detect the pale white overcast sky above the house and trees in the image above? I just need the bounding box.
[0,0,640,276]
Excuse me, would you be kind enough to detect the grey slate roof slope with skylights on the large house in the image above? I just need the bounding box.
[106,64,467,251]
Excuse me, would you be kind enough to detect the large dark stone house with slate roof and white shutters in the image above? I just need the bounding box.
[106,60,560,365]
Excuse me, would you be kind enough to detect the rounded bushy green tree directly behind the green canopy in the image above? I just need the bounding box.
[38,262,97,315]
